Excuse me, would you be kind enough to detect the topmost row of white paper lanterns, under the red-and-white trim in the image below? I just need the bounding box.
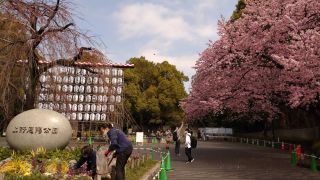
[48,66,123,76]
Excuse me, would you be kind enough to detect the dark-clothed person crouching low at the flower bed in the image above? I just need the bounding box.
[74,146,97,177]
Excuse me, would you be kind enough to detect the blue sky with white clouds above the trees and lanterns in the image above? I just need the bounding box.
[73,0,238,92]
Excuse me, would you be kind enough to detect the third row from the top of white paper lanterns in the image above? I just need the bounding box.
[41,85,122,94]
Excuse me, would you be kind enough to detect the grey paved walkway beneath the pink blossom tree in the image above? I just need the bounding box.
[167,142,320,180]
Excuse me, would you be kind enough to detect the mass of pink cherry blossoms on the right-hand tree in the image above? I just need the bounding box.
[181,0,320,120]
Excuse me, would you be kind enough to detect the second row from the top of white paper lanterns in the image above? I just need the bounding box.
[39,74,123,85]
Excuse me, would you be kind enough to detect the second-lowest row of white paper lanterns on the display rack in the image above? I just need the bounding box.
[37,103,114,112]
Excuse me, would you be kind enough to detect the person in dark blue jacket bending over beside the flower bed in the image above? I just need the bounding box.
[99,123,133,180]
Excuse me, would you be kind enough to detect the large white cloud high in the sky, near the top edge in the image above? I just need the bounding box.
[115,3,192,40]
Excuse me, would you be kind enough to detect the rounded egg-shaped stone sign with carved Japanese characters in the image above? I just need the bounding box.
[7,109,72,150]
